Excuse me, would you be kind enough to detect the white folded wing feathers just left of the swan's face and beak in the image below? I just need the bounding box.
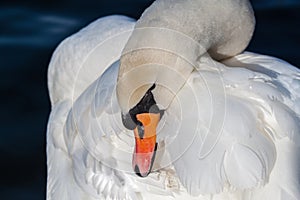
[64,62,143,199]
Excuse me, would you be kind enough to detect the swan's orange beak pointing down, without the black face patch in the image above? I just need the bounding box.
[132,113,160,177]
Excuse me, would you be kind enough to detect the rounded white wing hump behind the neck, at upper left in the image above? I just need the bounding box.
[48,15,135,105]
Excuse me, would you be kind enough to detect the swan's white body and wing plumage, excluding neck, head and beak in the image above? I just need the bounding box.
[47,0,300,200]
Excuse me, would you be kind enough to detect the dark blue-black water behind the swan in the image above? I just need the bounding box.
[0,0,300,200]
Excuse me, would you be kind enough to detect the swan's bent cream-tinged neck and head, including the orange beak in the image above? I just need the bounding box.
[116,1,255,176]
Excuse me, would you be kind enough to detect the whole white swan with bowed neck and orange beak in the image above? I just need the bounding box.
[47,0,300,200]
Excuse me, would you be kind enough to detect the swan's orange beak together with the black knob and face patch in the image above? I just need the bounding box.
[122,84,164,177]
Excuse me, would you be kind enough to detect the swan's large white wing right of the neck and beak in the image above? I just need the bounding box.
[162,53,300,199]
